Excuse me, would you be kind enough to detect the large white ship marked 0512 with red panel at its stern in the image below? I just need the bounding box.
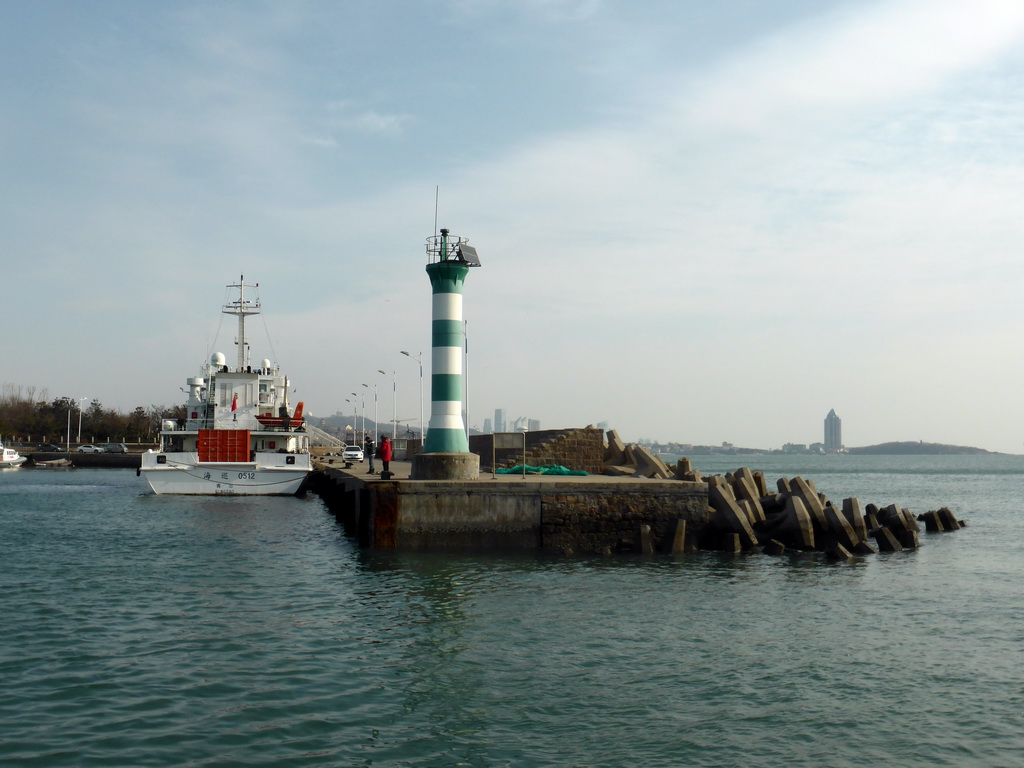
[139,278,312,496]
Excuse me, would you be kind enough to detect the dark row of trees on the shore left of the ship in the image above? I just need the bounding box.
[0,384,185,443]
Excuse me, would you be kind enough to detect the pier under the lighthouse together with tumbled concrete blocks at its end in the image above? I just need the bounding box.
[310,459,967,561]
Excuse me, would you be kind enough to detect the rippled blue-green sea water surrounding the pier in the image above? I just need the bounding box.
[0,456,1024,768]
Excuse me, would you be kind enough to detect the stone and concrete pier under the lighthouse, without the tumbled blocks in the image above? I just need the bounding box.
[310,460,710,553]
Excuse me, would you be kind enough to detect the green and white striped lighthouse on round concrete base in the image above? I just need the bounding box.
[413,229,480,480]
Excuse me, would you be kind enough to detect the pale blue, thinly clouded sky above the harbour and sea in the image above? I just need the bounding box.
[0,0,1024,454]
